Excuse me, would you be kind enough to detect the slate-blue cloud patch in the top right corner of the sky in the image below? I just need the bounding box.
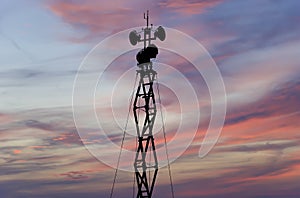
[204,1,300,55]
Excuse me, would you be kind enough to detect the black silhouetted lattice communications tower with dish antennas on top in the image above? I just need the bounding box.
[129,11,166,198]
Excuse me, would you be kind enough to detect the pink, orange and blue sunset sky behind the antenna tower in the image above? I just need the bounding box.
[0,0,300,198]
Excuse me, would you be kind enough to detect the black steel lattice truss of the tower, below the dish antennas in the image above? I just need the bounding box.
[133,62,158,198]
